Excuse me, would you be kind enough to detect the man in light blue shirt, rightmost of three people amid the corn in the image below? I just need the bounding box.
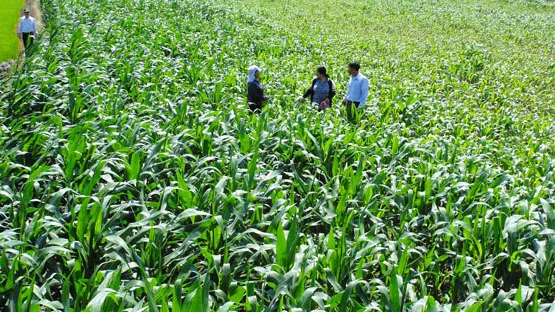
[343,62,368,121]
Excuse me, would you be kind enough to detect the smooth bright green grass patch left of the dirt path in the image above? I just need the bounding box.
[0,0,23,62]
